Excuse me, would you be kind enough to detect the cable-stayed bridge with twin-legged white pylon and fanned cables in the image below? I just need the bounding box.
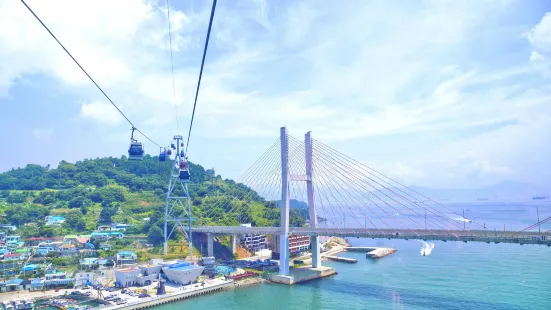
[167,128,551,275]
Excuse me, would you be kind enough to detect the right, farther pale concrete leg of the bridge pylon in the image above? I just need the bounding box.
[304,131,321,268]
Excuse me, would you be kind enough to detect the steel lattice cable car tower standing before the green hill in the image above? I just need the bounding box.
[163,135,193,256]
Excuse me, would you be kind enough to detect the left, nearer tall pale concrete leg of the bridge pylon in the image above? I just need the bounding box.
[279,127,289,275]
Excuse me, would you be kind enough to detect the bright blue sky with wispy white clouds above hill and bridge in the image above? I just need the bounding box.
[0,0,551,188]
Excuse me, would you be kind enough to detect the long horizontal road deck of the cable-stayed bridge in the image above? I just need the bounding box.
[192,226,551,246]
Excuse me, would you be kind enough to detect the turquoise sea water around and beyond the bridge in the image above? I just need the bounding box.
[156,201,551,310]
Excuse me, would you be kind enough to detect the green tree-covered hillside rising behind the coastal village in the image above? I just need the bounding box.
[0,155,302,244]
